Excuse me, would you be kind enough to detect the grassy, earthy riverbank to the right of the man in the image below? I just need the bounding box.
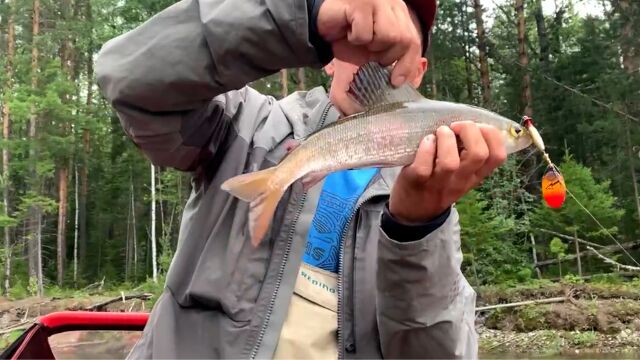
[477,282,640,359]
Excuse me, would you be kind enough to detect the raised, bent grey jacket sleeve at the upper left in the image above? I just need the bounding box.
[96,0,331,171]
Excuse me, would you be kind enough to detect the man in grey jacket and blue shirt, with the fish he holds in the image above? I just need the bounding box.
[96,0,529,359]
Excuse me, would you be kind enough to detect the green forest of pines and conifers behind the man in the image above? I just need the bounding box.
[0,0,640,358]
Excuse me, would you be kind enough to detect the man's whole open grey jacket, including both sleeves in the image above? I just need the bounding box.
[96,0,477,358]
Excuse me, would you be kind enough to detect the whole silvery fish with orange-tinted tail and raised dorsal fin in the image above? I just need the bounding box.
[221,62,532,246]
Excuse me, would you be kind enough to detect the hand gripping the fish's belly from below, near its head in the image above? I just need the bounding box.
[389,121,507,225]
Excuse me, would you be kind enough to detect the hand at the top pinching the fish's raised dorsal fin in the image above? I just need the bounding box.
[317,0,422,86]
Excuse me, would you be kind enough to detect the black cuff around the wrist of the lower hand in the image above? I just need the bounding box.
[380,202,451,242]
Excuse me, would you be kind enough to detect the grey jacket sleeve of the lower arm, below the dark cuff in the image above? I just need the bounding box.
[377,207,478,359]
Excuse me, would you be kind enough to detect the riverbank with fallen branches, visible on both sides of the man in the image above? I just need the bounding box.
[0,282,640,359]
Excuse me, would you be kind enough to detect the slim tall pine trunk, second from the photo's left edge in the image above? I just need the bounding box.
[28,0,43,296]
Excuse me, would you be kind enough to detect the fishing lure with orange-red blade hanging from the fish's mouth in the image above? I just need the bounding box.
[522,116,567,209]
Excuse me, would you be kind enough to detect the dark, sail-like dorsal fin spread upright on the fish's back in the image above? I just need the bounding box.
[348,62,424,111]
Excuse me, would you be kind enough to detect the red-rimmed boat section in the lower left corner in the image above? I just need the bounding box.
[0,311,149,359]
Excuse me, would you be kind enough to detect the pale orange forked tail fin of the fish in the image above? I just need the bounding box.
[221,167,285,246]
